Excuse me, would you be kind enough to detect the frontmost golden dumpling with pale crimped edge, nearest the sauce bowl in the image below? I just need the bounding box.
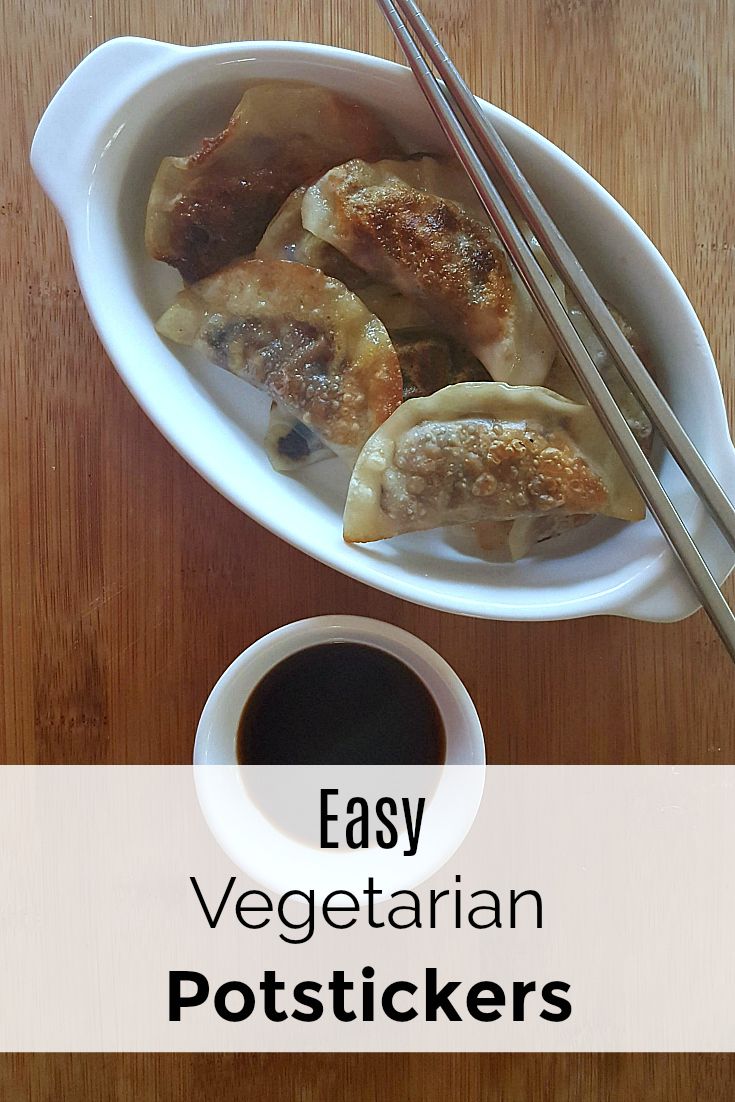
[344,382,645,543]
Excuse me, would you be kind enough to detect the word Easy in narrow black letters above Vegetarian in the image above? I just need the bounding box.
[320,788,426,857]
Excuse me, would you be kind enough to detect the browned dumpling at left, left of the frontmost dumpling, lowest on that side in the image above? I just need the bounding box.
[156,260,401,458]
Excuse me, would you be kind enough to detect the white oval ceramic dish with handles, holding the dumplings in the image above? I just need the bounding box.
[31,39,735,620]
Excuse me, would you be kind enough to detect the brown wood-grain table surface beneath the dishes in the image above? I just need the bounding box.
[0,0,735,1102]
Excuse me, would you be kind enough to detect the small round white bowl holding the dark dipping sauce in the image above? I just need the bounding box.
[194,616,485,898]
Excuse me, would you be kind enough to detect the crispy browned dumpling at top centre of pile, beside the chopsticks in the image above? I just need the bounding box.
[301,158,555,385]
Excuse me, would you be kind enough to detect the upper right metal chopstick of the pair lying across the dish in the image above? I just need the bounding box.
[396,0,735,548]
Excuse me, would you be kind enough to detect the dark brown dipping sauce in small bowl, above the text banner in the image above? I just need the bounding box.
[237,642,446,765]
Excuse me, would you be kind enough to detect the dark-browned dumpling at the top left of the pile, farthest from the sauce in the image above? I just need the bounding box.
[145,80,396,282]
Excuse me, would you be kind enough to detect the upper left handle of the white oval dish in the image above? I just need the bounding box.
[31,37,187,217]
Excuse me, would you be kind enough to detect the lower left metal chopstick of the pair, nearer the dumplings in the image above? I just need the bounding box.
[378,0,735,661]
